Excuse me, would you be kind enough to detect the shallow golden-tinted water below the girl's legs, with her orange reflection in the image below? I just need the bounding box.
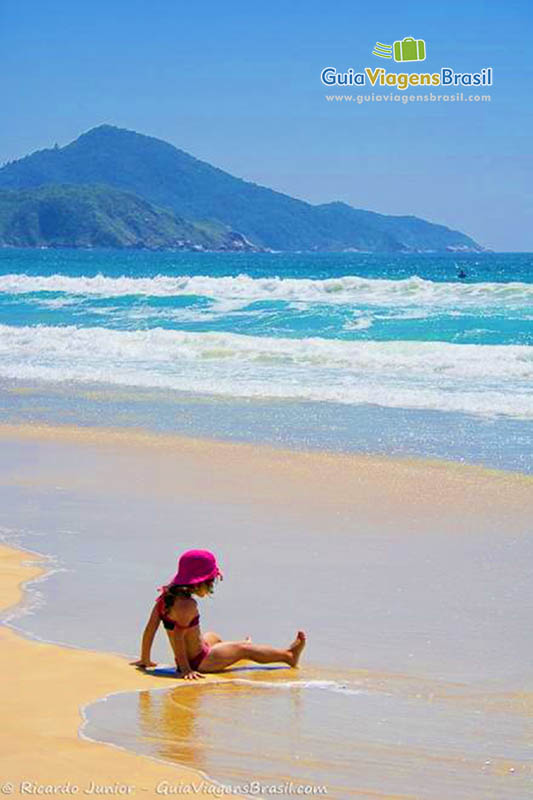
[109,668,533,800]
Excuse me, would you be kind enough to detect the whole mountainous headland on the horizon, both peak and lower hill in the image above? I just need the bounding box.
[0,125,484,253]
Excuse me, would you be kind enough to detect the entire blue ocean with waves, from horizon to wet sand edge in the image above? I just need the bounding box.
[0,249,533,472]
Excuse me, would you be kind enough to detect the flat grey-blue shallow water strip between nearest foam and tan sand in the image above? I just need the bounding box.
[0,376,533,474]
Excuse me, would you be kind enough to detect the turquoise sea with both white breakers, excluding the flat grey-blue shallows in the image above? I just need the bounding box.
[0,250,533,418]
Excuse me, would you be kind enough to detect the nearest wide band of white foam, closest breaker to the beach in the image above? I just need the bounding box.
[0,325,533,418]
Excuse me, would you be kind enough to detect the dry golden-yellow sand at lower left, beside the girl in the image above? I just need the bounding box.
[0,544,248,798]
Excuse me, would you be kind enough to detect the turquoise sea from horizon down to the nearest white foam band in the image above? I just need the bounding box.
[0,250,533,345]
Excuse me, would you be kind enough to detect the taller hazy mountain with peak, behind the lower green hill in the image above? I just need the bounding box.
[0,125,483,252]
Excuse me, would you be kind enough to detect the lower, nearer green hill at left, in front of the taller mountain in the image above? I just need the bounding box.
[0,184,255,250]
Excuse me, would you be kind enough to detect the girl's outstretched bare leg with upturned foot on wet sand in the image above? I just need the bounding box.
[198,631,305,672]
